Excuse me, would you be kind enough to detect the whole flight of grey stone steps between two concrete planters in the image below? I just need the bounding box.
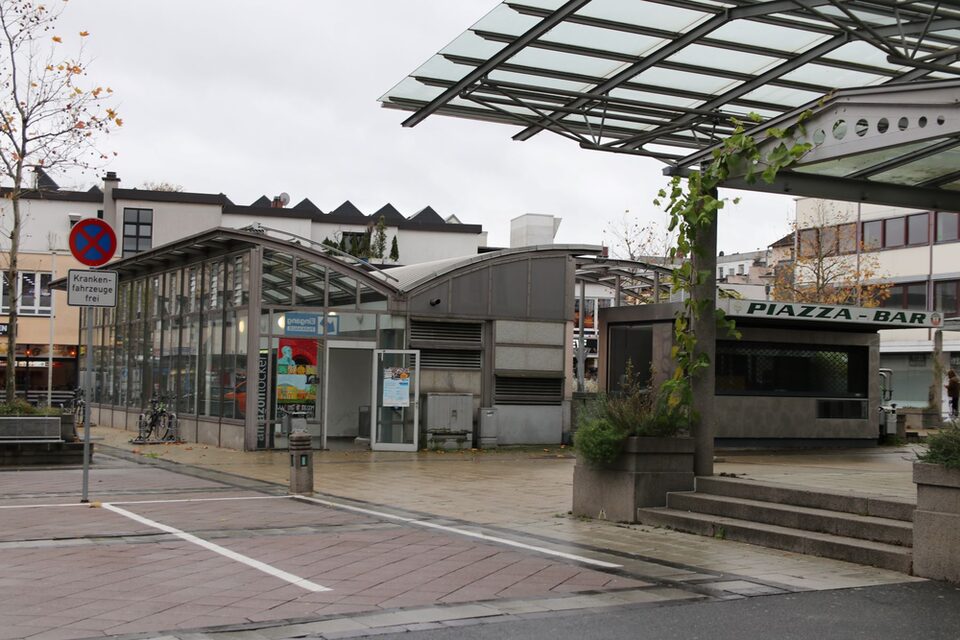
[637,476,915,574]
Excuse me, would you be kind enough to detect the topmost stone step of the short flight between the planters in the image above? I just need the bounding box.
[696,476,916,522]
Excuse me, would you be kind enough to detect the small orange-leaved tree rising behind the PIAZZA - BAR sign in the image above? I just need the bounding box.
[772,202,890,307]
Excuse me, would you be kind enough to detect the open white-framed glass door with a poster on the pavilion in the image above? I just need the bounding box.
[370,349,420,451]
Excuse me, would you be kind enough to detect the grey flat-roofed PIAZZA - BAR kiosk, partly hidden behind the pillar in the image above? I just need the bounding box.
[600,299,941,447]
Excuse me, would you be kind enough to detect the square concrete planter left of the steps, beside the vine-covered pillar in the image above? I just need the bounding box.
[573,437,694,522]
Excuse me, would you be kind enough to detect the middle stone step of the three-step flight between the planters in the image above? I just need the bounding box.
[667,492,913,547]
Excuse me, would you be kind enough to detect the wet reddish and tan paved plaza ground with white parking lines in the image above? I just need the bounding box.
[0,428,928,640]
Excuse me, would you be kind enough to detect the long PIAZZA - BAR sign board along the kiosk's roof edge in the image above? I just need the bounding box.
[717,299,943,329]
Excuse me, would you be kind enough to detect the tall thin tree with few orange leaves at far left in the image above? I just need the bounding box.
[0,0,123,402]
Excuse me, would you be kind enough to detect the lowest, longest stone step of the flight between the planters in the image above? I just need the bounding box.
[637,507,912,574]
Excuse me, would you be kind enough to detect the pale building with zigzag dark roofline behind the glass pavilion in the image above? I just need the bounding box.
[0,172,486,402]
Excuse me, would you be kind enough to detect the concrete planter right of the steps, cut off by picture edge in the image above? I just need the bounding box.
[913,462,960,582]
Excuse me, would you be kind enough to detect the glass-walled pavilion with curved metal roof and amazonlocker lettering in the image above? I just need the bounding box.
[69,229,594,450]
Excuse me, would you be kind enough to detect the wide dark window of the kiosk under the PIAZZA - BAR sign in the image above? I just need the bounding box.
[716,340,868,398]
